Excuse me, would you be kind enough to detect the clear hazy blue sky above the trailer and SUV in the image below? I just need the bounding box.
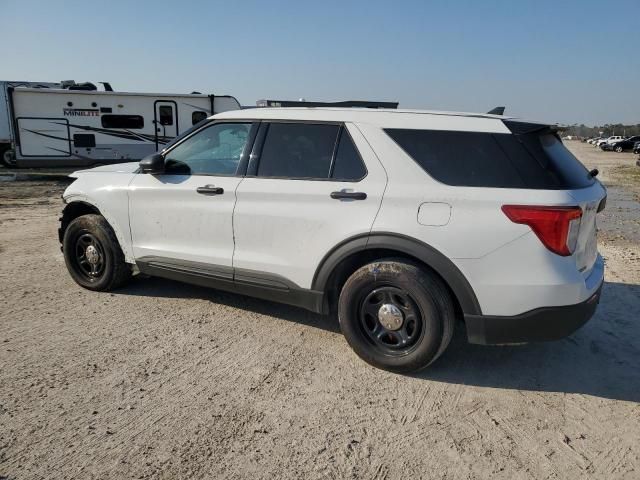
[0,0,640,125]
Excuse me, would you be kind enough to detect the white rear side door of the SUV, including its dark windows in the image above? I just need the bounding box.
[233,122,387,288]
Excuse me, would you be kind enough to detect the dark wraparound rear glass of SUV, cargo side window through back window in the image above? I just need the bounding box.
[385,125,594,189]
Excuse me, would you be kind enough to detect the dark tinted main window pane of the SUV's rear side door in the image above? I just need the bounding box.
[258,123,339,178]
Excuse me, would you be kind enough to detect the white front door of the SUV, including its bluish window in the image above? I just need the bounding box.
[129,123,252,271]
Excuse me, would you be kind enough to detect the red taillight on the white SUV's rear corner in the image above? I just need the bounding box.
[502,205,582,257]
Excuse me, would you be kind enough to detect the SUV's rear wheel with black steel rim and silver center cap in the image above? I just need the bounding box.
[338,259,455,373]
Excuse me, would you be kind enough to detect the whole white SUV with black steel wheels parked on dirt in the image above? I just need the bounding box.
[60,108,606,372]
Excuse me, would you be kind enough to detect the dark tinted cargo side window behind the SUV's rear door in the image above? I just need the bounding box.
[385,129,525,188]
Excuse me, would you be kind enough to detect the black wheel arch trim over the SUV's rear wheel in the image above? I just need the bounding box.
[311,232,482,315]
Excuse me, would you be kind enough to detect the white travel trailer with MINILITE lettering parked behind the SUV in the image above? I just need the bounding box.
[4,87,240,167]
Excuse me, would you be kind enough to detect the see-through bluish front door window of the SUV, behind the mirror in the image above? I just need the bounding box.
[165,123,251,175]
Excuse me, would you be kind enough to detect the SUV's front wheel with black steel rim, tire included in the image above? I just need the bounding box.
[62,214,132,292]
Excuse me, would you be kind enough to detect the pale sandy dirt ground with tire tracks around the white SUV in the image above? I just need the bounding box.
[0,142,640,480]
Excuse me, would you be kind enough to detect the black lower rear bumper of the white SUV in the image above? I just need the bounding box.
[465,283,602,345]
